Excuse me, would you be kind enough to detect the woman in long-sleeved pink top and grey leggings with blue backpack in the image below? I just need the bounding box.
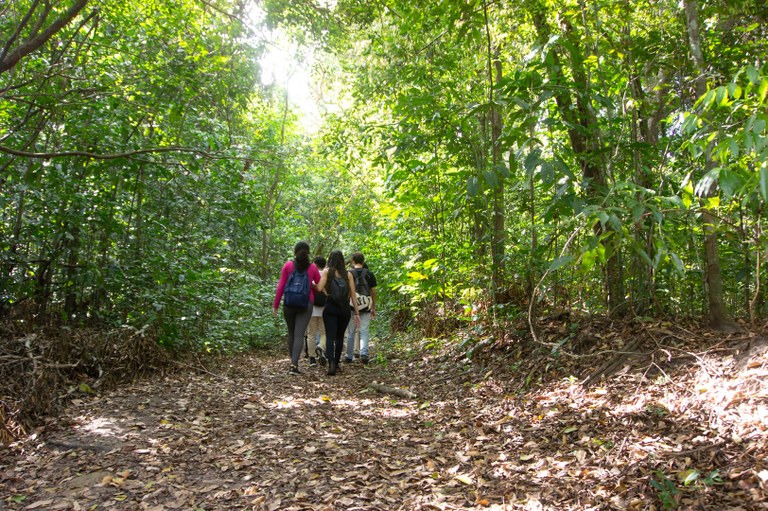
[272,241,320,374]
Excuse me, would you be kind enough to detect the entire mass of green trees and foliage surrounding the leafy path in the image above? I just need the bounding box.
[0,0,768,350]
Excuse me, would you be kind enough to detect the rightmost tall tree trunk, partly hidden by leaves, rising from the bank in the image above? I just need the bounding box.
[683,0,739,332]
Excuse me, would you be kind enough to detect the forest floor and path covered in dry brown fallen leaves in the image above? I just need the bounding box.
[0,318,768,511]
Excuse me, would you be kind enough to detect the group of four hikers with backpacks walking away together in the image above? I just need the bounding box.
[272,241,376,375]
